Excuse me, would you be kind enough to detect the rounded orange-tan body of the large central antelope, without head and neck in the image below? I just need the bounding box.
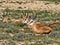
[31,23,52,33]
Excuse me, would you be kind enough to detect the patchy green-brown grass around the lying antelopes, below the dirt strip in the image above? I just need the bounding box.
[0,9,60,45]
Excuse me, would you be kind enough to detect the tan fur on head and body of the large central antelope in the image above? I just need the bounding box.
[22,15,52,33]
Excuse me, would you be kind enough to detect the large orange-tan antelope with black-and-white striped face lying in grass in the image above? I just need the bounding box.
[23,15,52,34]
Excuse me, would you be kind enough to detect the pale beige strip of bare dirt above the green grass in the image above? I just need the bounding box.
[0,0,60,11]
